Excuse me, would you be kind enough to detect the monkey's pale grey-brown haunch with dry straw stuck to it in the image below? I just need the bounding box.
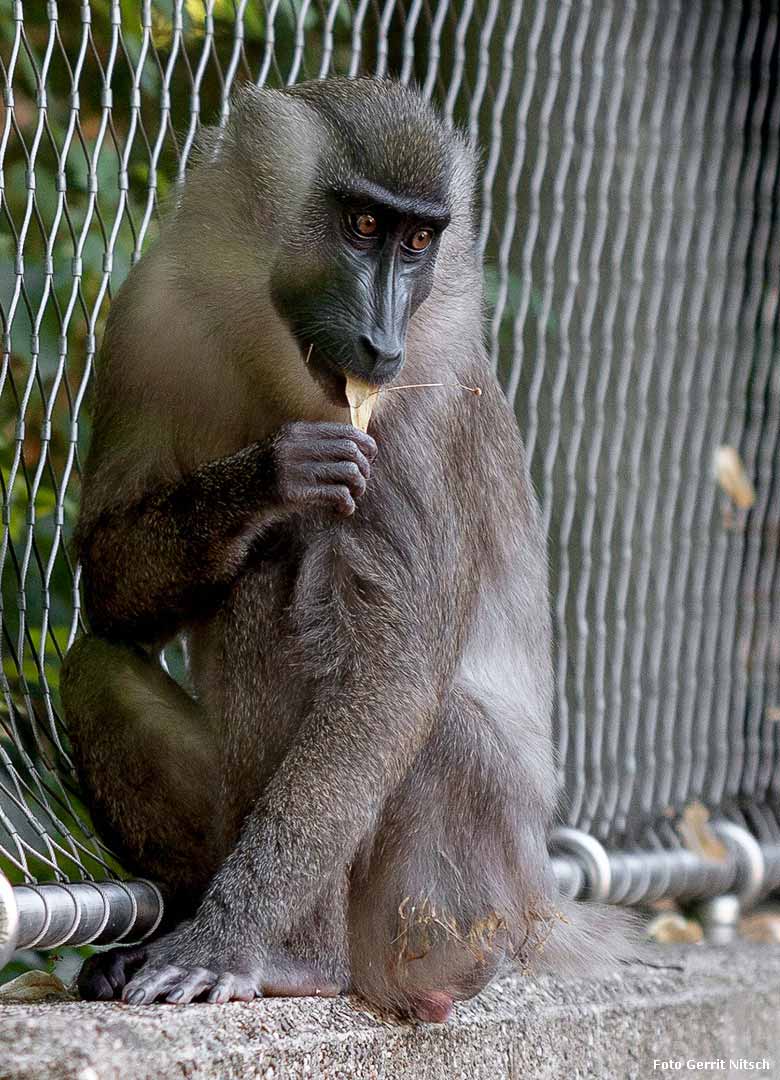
[349,690,544,1023]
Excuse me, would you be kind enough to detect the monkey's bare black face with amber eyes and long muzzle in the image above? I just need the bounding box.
[271,180,449,404]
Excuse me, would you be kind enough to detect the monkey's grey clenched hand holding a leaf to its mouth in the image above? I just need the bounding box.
[273,421,377,515]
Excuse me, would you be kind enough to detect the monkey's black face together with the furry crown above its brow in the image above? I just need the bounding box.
[271,80,452,404]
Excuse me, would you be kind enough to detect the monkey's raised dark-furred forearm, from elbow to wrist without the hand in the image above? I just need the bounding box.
[78,443,279,642]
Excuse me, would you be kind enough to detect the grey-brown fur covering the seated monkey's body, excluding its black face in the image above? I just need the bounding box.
[63,80,630,1020]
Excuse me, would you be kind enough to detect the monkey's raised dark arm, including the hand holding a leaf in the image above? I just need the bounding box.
[77,422,376,643]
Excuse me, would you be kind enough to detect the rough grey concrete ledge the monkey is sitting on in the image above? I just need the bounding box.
[0,945,780,1080]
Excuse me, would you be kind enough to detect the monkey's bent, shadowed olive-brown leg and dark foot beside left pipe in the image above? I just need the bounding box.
[62,637,224,997]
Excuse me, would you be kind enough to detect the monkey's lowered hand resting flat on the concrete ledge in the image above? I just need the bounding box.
[118,923,344,1005]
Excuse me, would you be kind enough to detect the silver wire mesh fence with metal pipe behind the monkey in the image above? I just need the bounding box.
[0,0,780,959]
